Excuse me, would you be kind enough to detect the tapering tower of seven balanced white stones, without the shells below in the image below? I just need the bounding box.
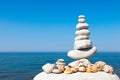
[68,15,97,59]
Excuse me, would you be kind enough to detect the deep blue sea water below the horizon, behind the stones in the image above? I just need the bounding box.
[0,52,120,80]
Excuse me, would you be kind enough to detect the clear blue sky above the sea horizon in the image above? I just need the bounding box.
[0,0,120,52]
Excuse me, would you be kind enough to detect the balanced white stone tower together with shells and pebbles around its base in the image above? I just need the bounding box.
[42,15,114,74]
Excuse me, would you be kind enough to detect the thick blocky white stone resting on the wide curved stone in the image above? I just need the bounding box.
[74,40,92,49]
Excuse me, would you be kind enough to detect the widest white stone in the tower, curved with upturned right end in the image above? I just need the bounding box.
[67,47,97,60]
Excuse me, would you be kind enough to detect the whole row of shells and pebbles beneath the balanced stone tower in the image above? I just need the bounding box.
[42,59,114,74]
